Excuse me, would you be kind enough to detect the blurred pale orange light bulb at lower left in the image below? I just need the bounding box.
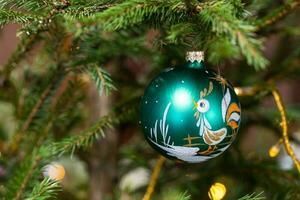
[43,163,66,181]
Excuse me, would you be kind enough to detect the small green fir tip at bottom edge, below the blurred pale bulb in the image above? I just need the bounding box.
[25,178,61,200]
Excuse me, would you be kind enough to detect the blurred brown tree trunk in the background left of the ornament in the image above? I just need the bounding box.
[87,83,118,200]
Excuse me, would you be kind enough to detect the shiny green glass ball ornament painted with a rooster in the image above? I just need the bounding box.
[140,52,241,163]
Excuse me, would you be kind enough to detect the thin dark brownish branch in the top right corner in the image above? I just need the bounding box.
[254,0,300,31]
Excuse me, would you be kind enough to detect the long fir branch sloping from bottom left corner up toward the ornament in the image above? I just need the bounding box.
[6,98,135,200]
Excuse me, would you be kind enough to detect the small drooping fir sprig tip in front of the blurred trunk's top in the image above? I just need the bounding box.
[88,65,117,95]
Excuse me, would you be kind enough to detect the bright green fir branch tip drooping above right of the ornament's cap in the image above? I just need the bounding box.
[200,1,268,69]
